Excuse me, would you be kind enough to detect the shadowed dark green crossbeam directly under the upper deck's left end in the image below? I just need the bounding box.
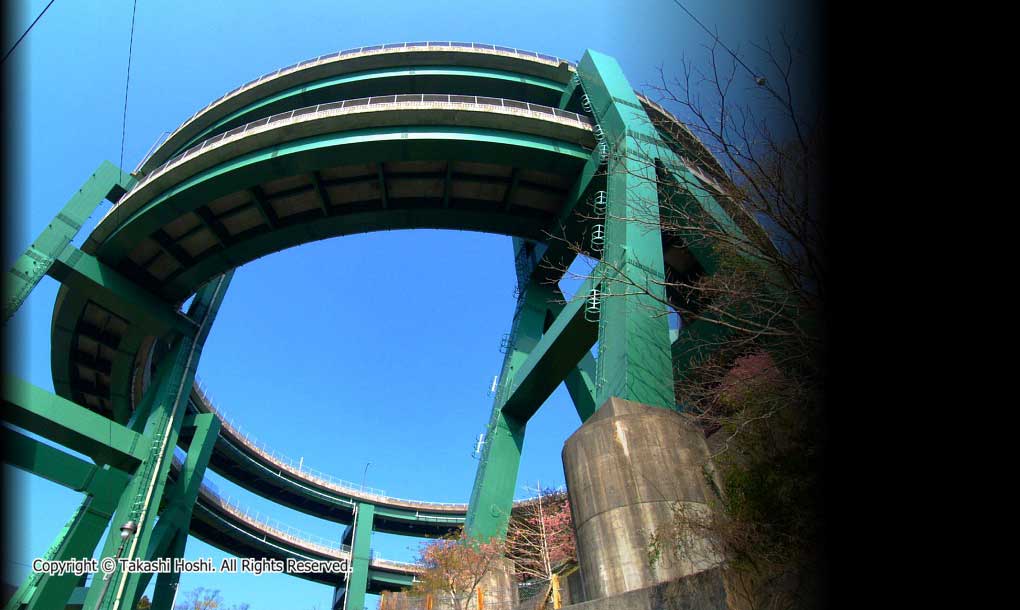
[49,246,195,335]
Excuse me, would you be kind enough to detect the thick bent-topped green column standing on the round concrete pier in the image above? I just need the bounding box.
[577,50,675,409]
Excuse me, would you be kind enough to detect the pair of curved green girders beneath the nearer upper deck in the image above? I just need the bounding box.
[96,126,590,299]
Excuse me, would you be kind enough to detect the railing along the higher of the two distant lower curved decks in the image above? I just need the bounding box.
[195,376,467,514]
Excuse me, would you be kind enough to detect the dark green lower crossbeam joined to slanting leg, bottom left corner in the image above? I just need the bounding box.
[0,426,130,610]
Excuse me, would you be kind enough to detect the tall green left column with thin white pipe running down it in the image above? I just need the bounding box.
[86,271,233,610]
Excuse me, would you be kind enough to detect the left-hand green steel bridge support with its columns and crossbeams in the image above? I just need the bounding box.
[3,169,233,610]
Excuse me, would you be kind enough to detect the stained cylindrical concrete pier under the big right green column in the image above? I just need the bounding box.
[563,398,719,600]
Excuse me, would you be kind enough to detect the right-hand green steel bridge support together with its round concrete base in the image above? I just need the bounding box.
[467,50,732,599]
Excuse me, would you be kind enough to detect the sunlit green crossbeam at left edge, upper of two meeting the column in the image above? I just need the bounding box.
[2,375,149,472]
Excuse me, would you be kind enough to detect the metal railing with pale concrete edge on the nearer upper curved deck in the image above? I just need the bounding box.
[103,94,592,225]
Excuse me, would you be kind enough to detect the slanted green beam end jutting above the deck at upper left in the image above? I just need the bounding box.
[3,161,136,324]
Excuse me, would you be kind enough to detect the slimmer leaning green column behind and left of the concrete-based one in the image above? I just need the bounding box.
[464,284,555,540]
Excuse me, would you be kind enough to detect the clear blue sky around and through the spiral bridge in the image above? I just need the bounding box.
[3,0,811,610]
